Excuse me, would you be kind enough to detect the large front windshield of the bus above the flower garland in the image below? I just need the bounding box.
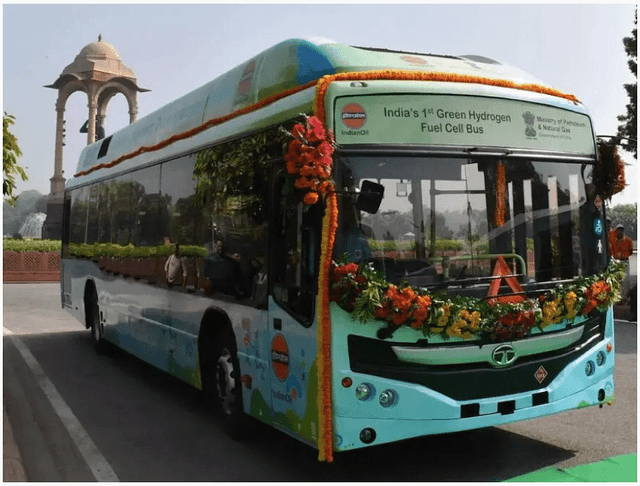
[334,155,606,298]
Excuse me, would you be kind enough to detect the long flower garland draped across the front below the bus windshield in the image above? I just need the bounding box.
[330,260,625,341]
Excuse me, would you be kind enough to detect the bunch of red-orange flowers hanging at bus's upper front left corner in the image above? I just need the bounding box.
[284,116,335,205]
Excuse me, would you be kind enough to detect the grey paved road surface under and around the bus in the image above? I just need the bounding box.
[3,284,637,481]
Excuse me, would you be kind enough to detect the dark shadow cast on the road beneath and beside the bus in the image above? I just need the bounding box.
[11,331,575,482]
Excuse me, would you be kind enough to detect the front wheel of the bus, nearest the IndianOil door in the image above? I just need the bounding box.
[211,326,249,440]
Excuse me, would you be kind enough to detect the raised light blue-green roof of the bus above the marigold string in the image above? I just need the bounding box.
[67,39,568,186]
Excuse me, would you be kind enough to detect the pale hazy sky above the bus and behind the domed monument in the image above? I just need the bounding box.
[2,3,638,205]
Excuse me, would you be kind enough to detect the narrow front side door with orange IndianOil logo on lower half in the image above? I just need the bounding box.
[267,170,323,443]
